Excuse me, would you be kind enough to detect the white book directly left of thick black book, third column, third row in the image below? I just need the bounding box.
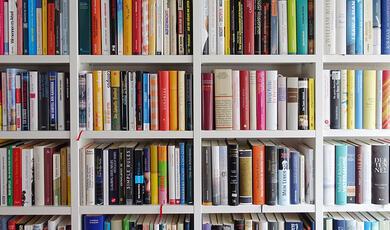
[218,140,229,205]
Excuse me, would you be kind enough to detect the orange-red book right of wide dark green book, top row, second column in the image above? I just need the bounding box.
[91,0,102,55]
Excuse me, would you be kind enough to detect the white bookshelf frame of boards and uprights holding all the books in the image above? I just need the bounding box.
[0,1,390,229]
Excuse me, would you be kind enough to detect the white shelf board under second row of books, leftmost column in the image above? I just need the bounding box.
[0,131,70,139]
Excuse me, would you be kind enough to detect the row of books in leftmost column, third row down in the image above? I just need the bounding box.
[0,141,70,207]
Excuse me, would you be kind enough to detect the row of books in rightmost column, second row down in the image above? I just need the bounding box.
[324,70,390,129]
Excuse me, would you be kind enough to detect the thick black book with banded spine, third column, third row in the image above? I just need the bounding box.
[227,140,240,205]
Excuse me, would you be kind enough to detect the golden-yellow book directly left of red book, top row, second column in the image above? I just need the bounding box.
[123,0,133,55]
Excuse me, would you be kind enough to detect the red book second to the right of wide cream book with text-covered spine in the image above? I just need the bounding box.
[240,70,249,130]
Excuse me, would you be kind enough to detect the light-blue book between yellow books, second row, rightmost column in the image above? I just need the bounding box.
[355,70,363,129]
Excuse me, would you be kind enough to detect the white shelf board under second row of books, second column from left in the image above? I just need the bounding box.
[80,131,194,139]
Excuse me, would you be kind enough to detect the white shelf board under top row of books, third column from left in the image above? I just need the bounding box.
[202,55,317,64]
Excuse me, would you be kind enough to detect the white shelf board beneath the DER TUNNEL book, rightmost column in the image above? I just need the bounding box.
[323,204,390,212]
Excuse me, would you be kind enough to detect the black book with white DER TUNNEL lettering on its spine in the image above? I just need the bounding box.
[371,145,389,204]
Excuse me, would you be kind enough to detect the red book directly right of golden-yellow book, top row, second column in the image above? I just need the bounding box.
[133,0,142,55]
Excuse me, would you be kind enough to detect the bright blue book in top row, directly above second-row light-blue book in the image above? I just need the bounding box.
[355,0,364,54]
